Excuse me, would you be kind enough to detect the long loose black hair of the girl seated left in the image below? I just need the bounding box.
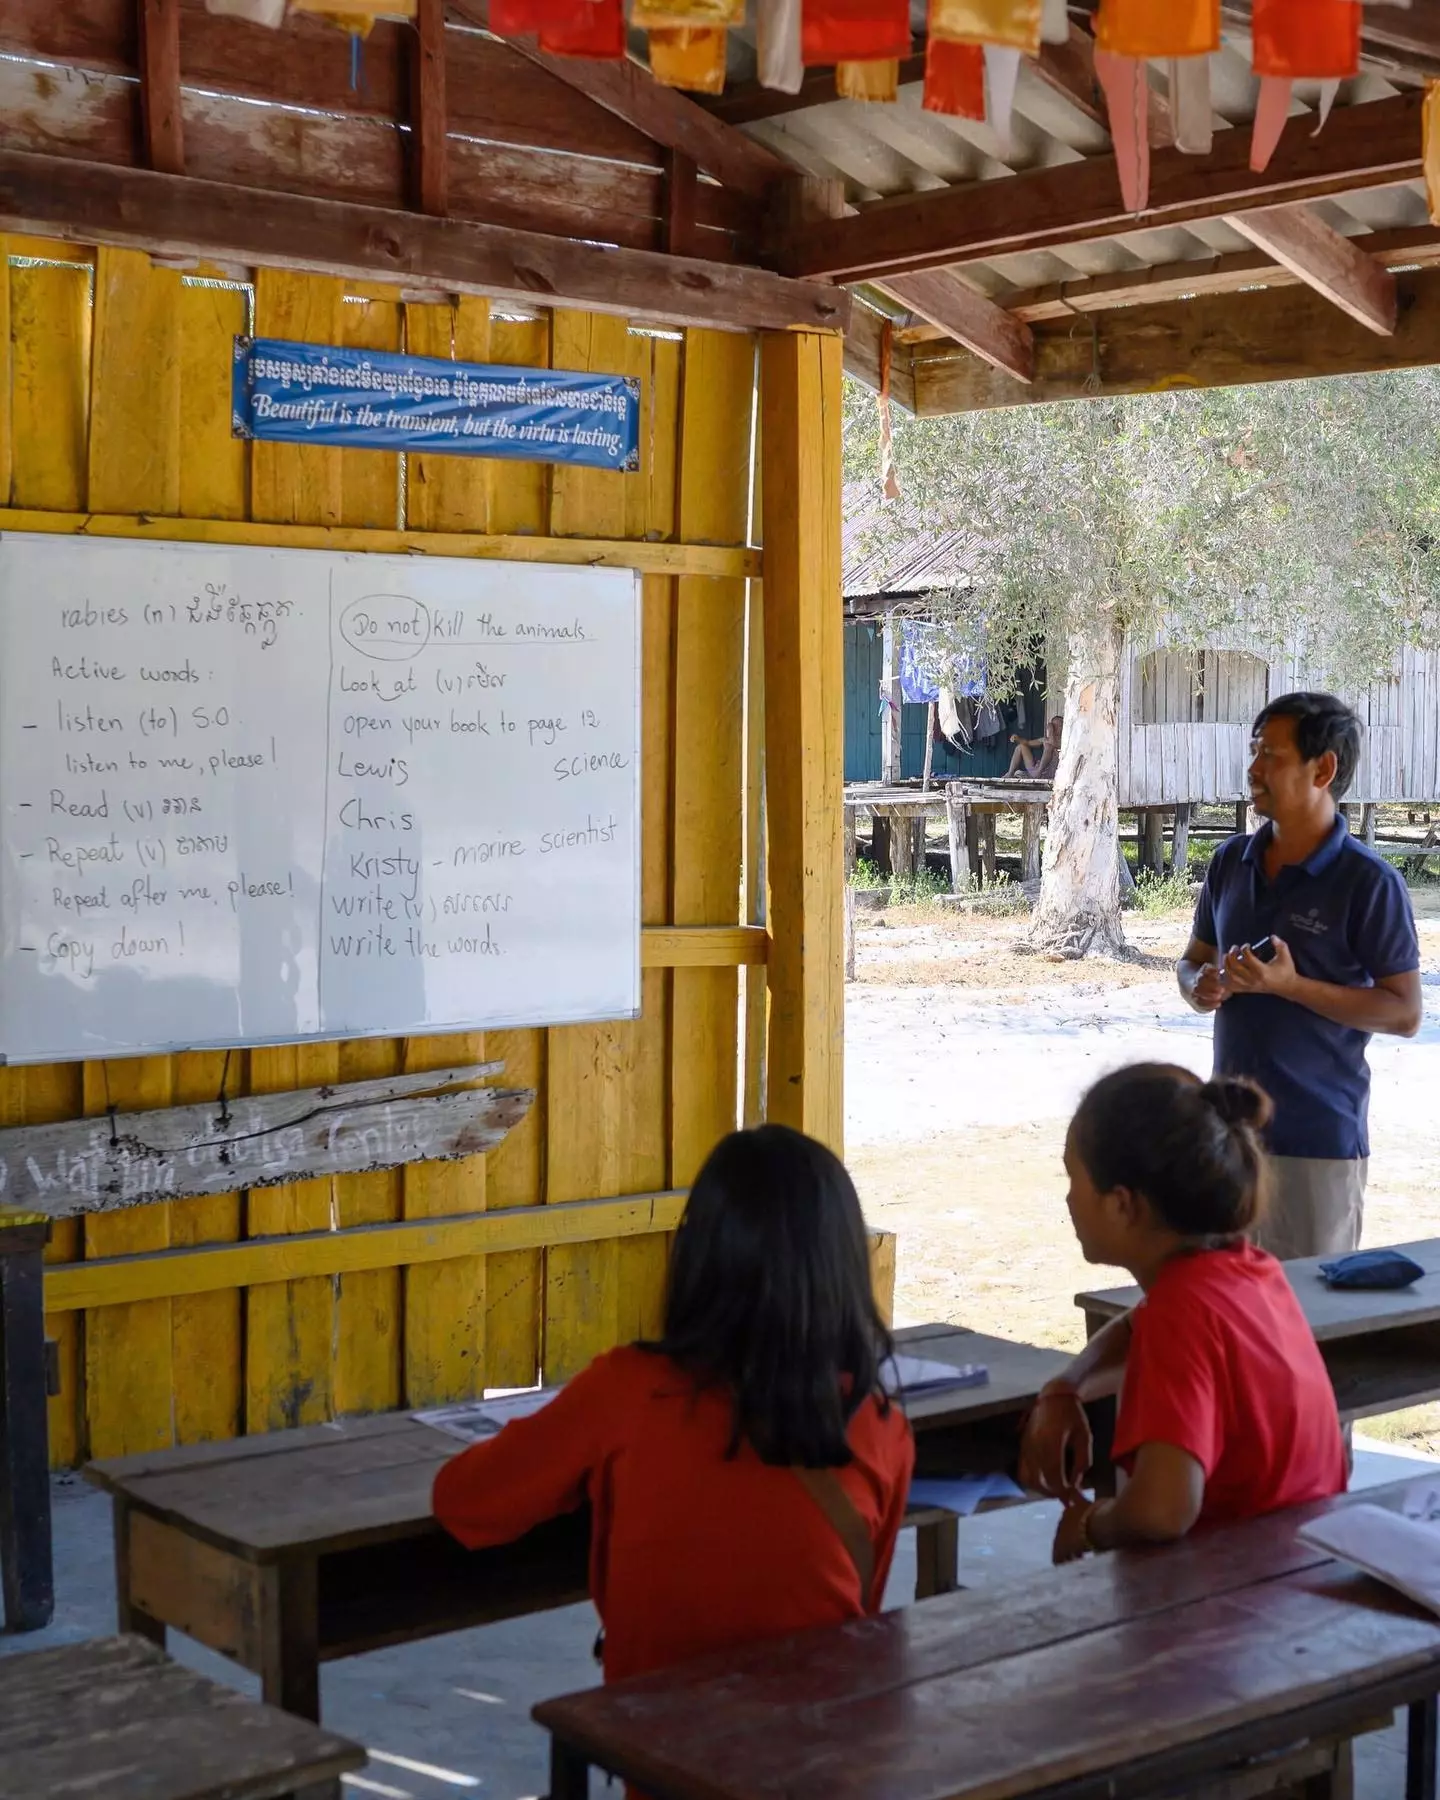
[644,1125,893,1469]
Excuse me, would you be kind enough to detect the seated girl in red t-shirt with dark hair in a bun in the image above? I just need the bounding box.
[1021,1062,1346,1562]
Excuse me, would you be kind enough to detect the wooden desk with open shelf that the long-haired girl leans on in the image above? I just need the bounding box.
[85,1325,1066,1719]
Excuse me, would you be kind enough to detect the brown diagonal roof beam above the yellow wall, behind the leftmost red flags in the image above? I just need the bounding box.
[450,0,796,200]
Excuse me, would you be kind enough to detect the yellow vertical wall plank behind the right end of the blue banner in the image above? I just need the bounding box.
[544,311,668,1381]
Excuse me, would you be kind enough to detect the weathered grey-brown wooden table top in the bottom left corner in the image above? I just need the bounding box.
[0,1638,365,1800]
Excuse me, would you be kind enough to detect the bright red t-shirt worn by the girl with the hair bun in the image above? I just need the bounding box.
[1114,1244,1346,1525]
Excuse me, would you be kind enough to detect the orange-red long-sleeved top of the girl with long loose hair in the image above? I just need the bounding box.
[434,1348,914,1681]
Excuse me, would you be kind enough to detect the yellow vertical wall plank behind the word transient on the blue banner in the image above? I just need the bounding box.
[401,299,496,1406]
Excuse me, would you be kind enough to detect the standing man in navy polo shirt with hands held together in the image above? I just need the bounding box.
[1175,693,1420,1256]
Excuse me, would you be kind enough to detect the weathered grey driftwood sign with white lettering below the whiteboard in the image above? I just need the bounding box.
[0,1062,535,1219]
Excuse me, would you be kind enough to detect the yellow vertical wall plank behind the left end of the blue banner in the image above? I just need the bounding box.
[245,270,344,1431]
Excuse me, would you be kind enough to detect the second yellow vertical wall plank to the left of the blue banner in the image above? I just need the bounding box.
[85,248,180,1456]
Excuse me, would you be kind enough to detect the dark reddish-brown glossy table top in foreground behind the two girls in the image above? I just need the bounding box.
[535,1483,1440,1800]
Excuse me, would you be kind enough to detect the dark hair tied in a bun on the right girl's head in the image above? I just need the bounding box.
[1071,1062,1274,1238]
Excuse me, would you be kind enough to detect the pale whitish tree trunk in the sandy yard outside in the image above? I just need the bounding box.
[1030,616,1125,959]
